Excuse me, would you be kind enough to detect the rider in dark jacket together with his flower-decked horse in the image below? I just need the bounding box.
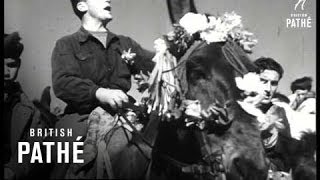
[52,0,272,179]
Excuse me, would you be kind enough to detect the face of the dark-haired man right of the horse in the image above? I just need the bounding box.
[260,69,280,104]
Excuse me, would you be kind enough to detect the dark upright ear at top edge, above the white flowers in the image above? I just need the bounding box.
[167,0,197,24]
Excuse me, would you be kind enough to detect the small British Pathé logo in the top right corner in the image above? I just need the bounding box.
[286,0,312,29]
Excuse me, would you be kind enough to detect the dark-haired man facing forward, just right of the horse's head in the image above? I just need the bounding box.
[254,57,291,172]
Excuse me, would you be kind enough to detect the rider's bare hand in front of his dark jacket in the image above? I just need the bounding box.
[96,88,129,109]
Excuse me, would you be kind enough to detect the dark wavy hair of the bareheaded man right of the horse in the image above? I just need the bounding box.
[254,57,283,79]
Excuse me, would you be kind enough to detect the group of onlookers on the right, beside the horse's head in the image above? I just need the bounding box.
[236,57,316,172]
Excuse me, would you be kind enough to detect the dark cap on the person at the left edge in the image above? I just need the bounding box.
[4,32,23,59]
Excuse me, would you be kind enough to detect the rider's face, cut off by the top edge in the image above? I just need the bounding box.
[84,0,112,21]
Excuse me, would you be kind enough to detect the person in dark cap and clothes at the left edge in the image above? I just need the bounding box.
[2,32,44,179]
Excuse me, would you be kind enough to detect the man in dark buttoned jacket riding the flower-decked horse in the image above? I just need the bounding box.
[52,0,154,177]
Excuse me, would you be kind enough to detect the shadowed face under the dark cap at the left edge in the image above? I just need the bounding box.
[4,58,19,81]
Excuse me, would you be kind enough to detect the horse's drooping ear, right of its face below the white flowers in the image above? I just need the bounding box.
[222,41,258,76]
